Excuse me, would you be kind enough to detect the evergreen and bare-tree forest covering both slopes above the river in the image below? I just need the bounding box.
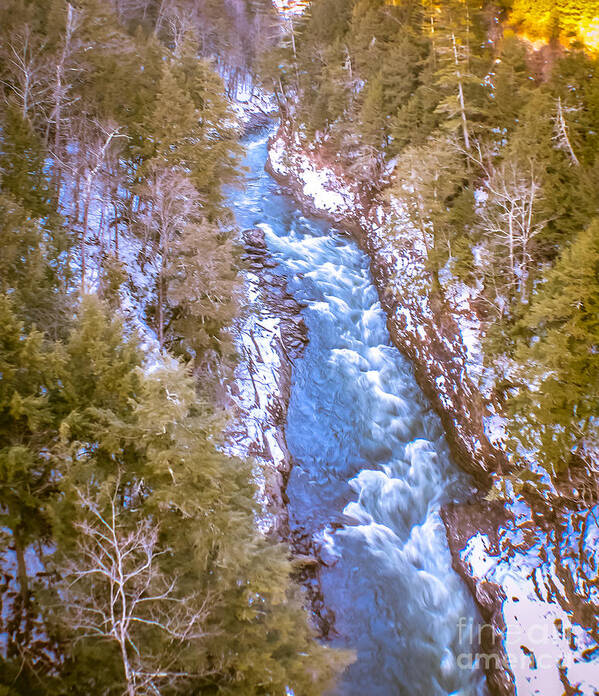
[0,0,599,696]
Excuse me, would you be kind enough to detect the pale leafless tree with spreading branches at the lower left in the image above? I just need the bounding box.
[59,477,214,696]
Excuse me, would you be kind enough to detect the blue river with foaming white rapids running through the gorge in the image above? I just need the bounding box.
[229,135,485,696]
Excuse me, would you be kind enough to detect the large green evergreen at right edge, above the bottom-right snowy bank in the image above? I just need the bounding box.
[508,220,599,472]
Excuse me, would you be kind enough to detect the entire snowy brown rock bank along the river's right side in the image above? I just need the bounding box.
[269,123,599,696]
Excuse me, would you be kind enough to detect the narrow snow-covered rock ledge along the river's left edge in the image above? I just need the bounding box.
[228,228,306,538]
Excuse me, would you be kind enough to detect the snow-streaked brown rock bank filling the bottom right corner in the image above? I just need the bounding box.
[444,499,599,696]
